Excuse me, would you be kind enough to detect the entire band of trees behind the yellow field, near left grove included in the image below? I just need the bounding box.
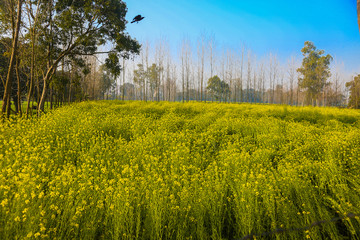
[0,0,360,119]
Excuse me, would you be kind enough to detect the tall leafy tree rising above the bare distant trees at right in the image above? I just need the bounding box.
[297,41,333,105]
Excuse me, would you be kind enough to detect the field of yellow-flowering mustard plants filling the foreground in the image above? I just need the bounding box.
[0,101,360,240]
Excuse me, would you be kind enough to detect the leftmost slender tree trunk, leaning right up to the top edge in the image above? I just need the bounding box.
[2,0,22,118]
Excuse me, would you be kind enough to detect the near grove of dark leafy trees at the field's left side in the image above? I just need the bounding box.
[0,0,140,116]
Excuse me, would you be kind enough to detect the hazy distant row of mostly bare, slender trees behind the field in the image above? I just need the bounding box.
[114,36,358,107]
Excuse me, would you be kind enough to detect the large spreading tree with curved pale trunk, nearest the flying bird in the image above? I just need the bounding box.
[34,0,140,113]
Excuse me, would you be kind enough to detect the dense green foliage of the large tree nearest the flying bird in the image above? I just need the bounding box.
[48,0,140,71]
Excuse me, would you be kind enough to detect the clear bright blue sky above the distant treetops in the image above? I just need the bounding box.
[124,0,360,73]
